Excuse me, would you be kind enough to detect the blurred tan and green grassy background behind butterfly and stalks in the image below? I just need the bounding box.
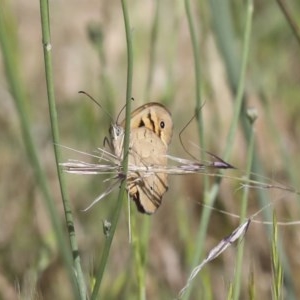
[0,0,300,299]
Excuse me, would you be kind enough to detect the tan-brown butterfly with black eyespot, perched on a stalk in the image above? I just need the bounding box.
[110,102,173,214]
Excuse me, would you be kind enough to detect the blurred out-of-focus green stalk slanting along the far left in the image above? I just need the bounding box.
[0,2,78,298]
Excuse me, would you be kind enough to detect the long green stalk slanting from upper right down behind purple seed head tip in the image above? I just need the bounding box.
[184,0,253,299]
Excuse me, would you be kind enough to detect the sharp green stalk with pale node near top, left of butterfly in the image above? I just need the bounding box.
[40,0,86,299]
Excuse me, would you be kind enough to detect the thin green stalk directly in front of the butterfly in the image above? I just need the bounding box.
[91,0,133,300]
